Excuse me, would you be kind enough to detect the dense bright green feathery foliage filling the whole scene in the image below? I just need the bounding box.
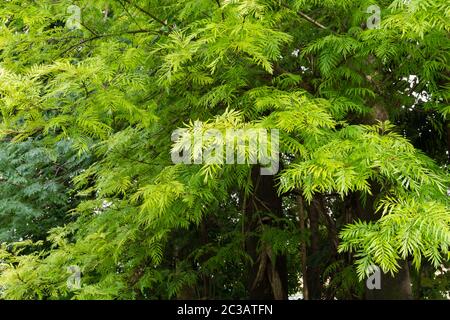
[0,0,450,299]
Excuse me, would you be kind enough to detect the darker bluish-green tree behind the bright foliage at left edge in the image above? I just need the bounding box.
[0,139,87,243]
